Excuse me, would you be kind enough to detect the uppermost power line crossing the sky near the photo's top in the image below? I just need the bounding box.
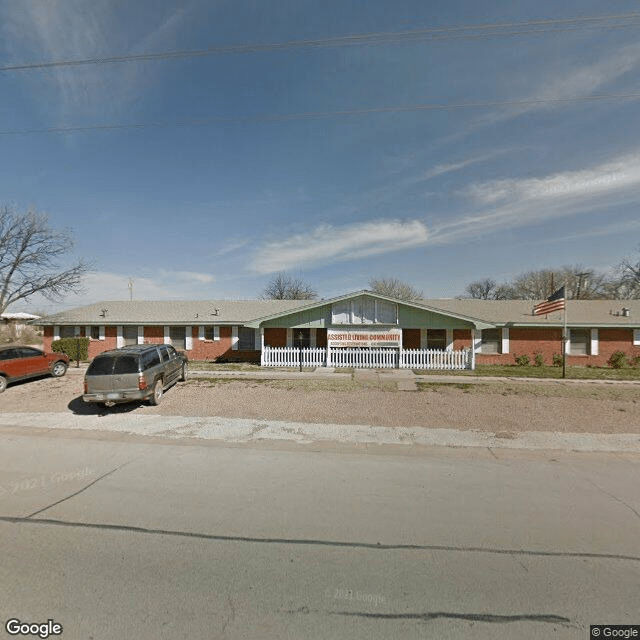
[0,12,640,73]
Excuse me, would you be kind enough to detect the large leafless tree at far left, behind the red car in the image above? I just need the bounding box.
[0,207,88,313]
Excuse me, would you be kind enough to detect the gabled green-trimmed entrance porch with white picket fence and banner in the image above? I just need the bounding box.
[248,291,492,370]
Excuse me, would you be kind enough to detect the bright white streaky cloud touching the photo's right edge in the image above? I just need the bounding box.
[432,151,640,242]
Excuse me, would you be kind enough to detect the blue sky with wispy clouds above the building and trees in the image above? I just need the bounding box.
[0,0,640,311]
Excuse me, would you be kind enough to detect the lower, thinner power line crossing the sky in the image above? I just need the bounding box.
[0,92,640,136]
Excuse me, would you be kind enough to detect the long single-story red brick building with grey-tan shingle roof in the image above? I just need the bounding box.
[38,291,640,368]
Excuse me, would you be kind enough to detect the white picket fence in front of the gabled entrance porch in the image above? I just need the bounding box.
[261,347,475,370]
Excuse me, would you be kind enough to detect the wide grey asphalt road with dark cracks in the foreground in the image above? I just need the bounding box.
[0,429,640,640]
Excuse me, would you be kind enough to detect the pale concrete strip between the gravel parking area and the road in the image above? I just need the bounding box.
[0,412,640,453]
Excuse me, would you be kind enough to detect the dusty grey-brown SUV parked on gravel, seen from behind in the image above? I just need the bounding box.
[82,344,188,405]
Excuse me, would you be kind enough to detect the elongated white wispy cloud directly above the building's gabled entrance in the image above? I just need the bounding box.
[252,220,429,274]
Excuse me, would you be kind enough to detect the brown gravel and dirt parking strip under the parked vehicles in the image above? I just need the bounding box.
[0,369,640,437]
